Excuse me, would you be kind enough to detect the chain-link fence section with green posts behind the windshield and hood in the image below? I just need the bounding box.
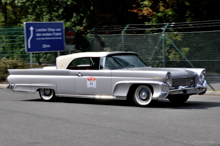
[92,26,220,90]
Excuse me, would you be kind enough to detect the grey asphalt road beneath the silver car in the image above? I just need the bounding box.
[0,89,220,146]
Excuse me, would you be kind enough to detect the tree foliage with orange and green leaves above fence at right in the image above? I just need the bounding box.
[132,0,220,23]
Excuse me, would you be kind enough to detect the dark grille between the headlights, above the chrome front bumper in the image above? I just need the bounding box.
[172,77,196,88]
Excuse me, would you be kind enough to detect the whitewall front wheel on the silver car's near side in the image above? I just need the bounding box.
[133,85,153,106]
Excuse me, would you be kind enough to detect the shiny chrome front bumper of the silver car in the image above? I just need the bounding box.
[169,81,207,95]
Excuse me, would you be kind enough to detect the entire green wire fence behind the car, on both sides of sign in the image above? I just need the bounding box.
[0,24,220,90]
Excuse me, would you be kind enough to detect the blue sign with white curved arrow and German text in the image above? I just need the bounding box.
[24,22,65,52]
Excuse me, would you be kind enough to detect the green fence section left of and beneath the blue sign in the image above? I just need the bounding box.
[0,27,68,64]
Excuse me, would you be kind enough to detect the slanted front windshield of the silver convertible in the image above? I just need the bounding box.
[105,55,146,69]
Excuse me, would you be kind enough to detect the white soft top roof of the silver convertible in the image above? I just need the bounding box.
[56,52,137,69]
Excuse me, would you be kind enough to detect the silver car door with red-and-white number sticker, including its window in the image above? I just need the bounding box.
[68,57,112,95]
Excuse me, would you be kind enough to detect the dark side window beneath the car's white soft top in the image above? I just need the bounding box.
[67,57,100,70]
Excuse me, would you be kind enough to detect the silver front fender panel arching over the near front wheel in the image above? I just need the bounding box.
[112,70,169,99]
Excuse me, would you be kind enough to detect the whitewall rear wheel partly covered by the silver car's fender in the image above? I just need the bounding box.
[39,89,56,101]
